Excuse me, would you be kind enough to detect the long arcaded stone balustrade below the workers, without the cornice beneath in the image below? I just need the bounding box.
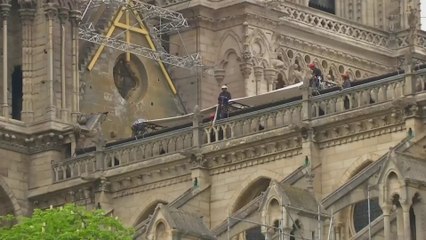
[52,69,426,182]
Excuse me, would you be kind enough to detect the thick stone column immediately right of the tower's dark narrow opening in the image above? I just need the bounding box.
[19,8,35,122]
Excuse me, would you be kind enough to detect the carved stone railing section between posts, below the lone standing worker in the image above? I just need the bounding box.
[203,101,302,144]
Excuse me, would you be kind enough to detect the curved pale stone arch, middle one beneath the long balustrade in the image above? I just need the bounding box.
[228,170,282,214]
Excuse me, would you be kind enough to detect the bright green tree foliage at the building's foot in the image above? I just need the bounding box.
[0,204,134,240]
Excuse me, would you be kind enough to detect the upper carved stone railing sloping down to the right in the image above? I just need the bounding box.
[271,2,390,48]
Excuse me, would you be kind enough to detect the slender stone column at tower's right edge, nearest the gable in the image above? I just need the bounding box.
[70,10,80,122]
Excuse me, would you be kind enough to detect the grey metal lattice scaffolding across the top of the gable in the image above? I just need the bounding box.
[79,0,202,68]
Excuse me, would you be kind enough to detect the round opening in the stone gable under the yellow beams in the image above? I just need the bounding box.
[113,53,148,101]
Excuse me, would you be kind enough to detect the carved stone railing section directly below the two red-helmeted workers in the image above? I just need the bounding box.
[312,75,405,118]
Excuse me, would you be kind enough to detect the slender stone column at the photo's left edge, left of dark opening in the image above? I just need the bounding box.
[0,3,11,118]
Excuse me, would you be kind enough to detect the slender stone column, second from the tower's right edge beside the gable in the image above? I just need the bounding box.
[59,8,69,122]
